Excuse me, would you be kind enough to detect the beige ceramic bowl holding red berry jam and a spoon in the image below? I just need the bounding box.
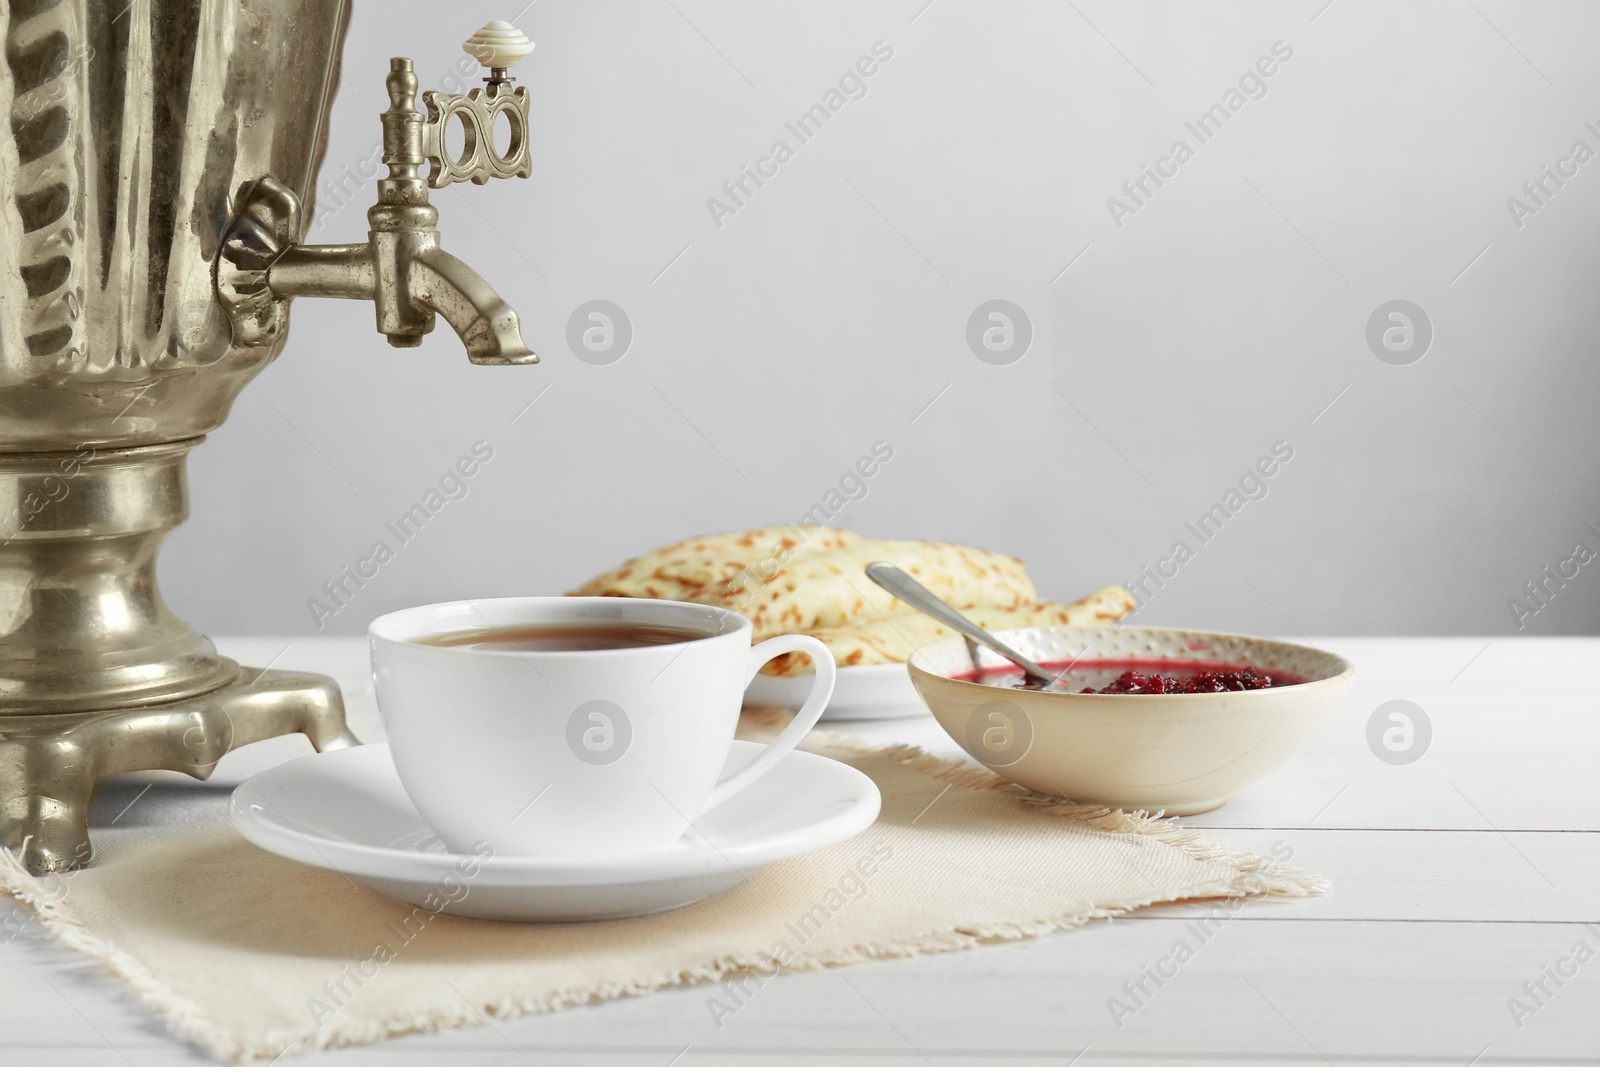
[909,625,1355,814]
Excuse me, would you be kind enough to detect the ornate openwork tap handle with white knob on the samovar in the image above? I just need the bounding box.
[422,22,533,189]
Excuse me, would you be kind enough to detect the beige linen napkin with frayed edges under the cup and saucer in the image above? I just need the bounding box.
[0,713,1323,1062]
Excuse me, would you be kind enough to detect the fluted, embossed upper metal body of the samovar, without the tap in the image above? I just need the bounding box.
[0,0,349,451]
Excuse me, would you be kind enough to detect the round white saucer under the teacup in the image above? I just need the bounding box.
[230,741,878,923]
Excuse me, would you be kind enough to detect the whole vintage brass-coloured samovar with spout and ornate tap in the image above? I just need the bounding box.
[0,0,536,873]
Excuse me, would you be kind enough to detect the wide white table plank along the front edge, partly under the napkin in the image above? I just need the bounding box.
[9,920,1600,1064]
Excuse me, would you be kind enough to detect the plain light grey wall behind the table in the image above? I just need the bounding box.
[163,0,1600,635]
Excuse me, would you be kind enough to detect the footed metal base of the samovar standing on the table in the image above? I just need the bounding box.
[0,667,360,875]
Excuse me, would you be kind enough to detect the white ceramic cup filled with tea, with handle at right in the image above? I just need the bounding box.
[368,597,834,857]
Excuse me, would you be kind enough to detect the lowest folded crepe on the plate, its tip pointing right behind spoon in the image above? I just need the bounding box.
[762,585,1136,677]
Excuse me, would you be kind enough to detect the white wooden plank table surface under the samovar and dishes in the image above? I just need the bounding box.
[0,638,1600,1067]
